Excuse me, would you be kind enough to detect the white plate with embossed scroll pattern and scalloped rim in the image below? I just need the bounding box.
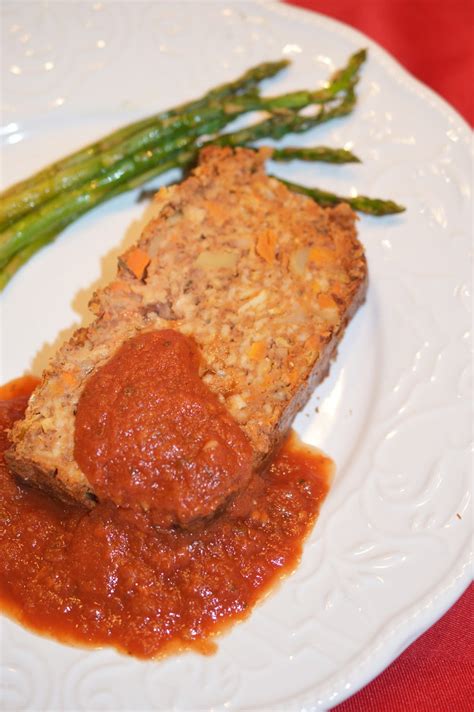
[1,2,471,712]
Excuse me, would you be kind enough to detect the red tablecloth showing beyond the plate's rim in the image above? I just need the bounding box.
[282,0,474,712]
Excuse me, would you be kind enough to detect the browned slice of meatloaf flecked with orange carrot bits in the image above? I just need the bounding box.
[7,147,367,504]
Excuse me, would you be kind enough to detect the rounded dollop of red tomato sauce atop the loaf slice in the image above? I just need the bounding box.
[74,329,253,527]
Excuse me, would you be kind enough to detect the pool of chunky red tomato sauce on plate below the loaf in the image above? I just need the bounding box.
[0,377,332,658]
